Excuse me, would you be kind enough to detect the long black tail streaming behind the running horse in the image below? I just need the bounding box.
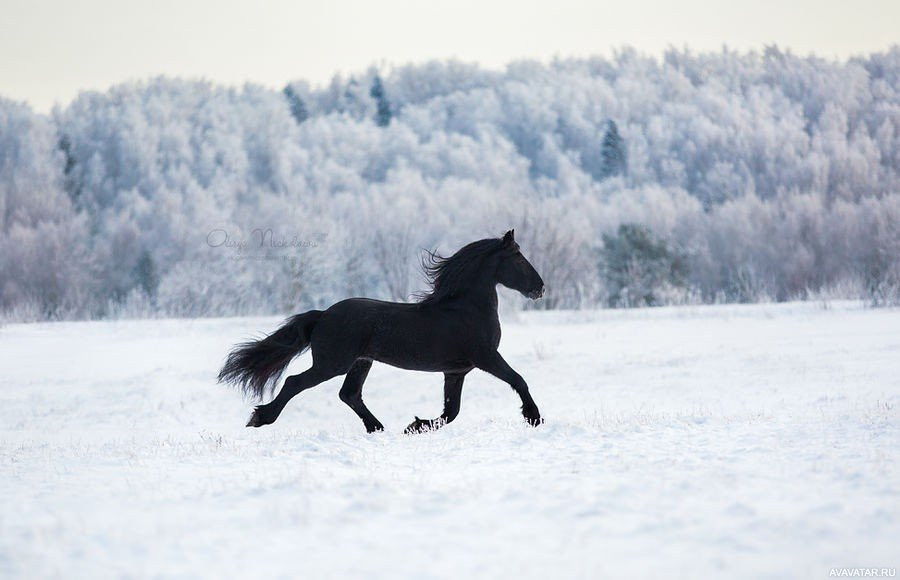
[219,310,322,400]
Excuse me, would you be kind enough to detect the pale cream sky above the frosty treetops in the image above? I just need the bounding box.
[0,0,900,112]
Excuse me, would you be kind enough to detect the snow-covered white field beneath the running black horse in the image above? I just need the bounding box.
[0,304,900,578]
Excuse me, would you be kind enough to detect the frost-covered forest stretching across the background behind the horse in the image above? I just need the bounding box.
[0,47,900,321]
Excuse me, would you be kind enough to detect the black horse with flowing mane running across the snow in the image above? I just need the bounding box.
[219,230,544,433]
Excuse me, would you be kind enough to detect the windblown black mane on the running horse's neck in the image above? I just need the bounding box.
[417,238,503,304]
